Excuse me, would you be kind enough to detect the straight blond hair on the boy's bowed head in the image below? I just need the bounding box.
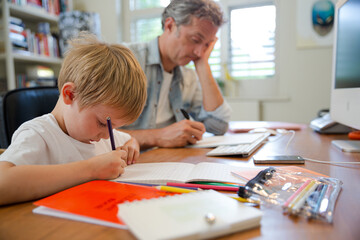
[58,32,146,123]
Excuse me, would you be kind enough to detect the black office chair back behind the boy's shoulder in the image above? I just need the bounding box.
[0,87,59,148]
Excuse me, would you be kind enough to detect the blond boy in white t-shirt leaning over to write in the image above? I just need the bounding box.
[0,33,146,205]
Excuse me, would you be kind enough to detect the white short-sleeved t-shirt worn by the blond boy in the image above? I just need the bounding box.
[0,113,131,165]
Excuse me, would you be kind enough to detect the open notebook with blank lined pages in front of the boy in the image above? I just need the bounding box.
[114,162,246,185]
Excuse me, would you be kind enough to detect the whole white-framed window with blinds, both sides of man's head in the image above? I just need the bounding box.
[122,0,276,88]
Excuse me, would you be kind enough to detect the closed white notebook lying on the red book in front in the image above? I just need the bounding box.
[118,190,262,240]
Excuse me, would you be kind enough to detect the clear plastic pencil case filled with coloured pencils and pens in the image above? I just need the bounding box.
[237,167,342,223]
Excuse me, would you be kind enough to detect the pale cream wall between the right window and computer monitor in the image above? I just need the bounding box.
[263,0,332,123]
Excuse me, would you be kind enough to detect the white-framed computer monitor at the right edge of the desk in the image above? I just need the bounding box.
[330,0,360,151]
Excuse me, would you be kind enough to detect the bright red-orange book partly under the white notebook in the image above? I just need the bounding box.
[33,180,176,228]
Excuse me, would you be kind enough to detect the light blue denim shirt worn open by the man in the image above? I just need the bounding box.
[122,38,231,135]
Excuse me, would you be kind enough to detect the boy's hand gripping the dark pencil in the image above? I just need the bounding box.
[88,149,127,180]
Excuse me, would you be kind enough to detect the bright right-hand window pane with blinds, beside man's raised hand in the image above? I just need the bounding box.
[229,5,275,79]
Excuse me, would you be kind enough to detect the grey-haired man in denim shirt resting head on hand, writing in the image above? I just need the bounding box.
[122,0,231,149]
